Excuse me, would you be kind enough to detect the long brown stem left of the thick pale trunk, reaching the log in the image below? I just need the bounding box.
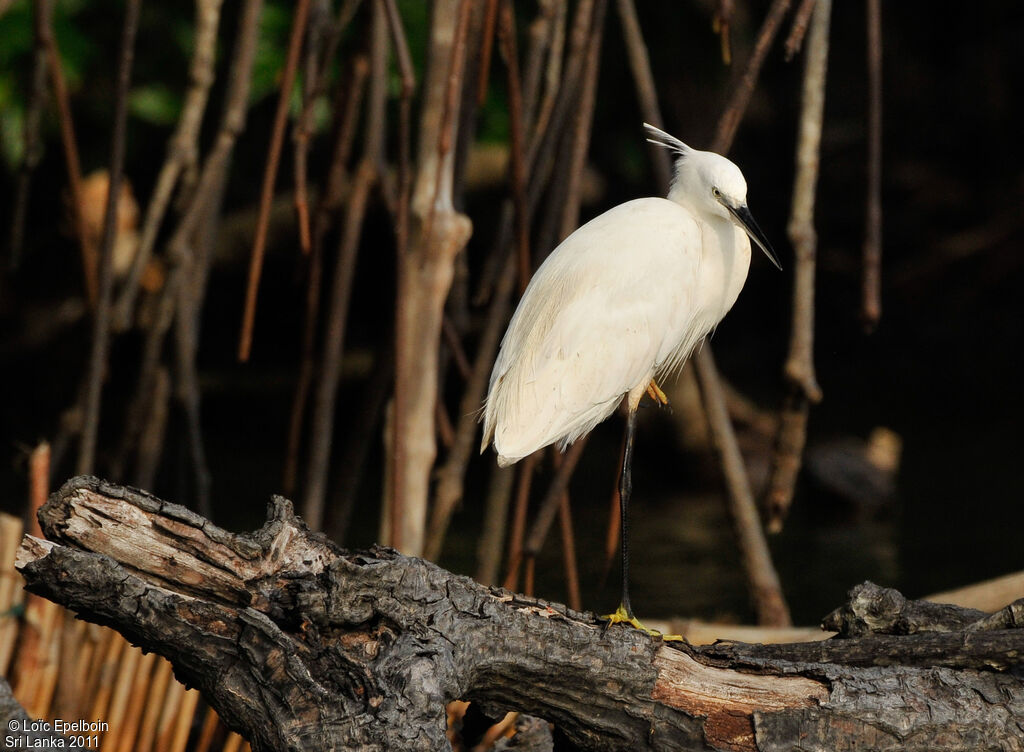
[303,4,387,530]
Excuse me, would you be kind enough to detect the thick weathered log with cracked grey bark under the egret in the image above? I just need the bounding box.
[17,477,1024,751]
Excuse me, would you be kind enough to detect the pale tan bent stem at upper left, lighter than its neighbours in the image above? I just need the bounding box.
[114,0,222,329]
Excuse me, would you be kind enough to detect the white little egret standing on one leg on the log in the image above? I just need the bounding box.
[480,123,781,627]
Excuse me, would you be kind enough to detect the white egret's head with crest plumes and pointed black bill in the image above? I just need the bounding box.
[644,123,782,269]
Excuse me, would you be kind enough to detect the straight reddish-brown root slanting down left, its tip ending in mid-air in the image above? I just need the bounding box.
[239,0,309,361]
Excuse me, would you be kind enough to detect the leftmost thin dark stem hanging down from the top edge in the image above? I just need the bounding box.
[8,2,50,268]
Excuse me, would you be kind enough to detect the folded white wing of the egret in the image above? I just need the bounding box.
[484,199,699,461]
